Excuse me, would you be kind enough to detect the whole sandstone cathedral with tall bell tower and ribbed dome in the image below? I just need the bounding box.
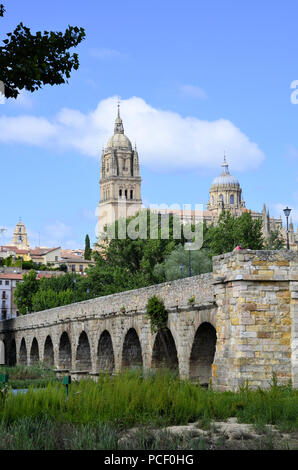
[98,108,298,250]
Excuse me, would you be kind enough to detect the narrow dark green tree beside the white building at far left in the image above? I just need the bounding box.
[14,270,39,315]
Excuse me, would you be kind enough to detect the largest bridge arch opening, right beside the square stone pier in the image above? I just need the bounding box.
[189,322,216,386]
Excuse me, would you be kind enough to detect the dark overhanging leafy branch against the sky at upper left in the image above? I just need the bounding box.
[0,4,85,98]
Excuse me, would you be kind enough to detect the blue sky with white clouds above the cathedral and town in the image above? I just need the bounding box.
[0,0,298,248]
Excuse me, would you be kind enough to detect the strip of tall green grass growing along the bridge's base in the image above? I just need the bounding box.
[0,371,298,431]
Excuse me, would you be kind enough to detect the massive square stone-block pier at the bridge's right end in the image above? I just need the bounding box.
[213,250,298,389]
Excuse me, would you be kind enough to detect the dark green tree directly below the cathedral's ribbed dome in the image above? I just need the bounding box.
[203,211,263,256]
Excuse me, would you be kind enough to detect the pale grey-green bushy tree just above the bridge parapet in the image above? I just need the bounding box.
[154,245,212,281]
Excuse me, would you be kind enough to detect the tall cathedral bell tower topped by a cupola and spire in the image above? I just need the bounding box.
[97,104,142,239]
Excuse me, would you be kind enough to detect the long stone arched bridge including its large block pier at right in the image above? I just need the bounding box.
[0,250,298,390]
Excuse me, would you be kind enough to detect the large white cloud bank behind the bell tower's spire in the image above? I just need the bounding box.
[0,97,265,171]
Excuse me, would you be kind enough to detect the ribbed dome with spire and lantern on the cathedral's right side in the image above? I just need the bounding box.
[207,157,245,216]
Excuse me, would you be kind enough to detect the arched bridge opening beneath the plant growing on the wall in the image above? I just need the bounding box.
[151,328,179,370]
